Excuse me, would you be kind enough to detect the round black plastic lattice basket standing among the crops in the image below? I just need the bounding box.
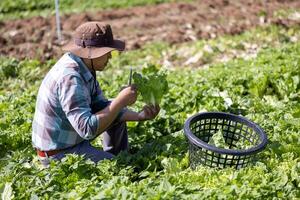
[184,112,268,169]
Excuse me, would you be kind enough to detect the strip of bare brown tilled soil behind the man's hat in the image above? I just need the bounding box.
[0,0,300,60]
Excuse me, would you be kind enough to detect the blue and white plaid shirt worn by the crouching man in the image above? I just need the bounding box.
[32,53,121,151]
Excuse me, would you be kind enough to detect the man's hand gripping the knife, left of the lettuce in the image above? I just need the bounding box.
[116,85,137,107]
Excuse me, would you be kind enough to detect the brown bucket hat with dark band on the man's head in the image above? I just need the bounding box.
[62,21,125,59]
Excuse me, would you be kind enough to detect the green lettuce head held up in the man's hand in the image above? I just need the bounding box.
[132,65,169,105]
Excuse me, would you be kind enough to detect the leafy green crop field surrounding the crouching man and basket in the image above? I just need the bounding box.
[0,22,300,199]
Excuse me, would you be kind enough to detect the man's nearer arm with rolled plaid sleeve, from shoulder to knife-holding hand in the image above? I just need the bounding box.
[58,74,137,139]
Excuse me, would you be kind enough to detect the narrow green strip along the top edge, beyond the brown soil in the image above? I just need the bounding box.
[0,0,191,20]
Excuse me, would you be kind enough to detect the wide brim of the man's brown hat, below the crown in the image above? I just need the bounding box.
[62,40,125,59]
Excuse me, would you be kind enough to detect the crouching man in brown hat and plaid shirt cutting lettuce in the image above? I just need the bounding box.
[32,22,160,166]
